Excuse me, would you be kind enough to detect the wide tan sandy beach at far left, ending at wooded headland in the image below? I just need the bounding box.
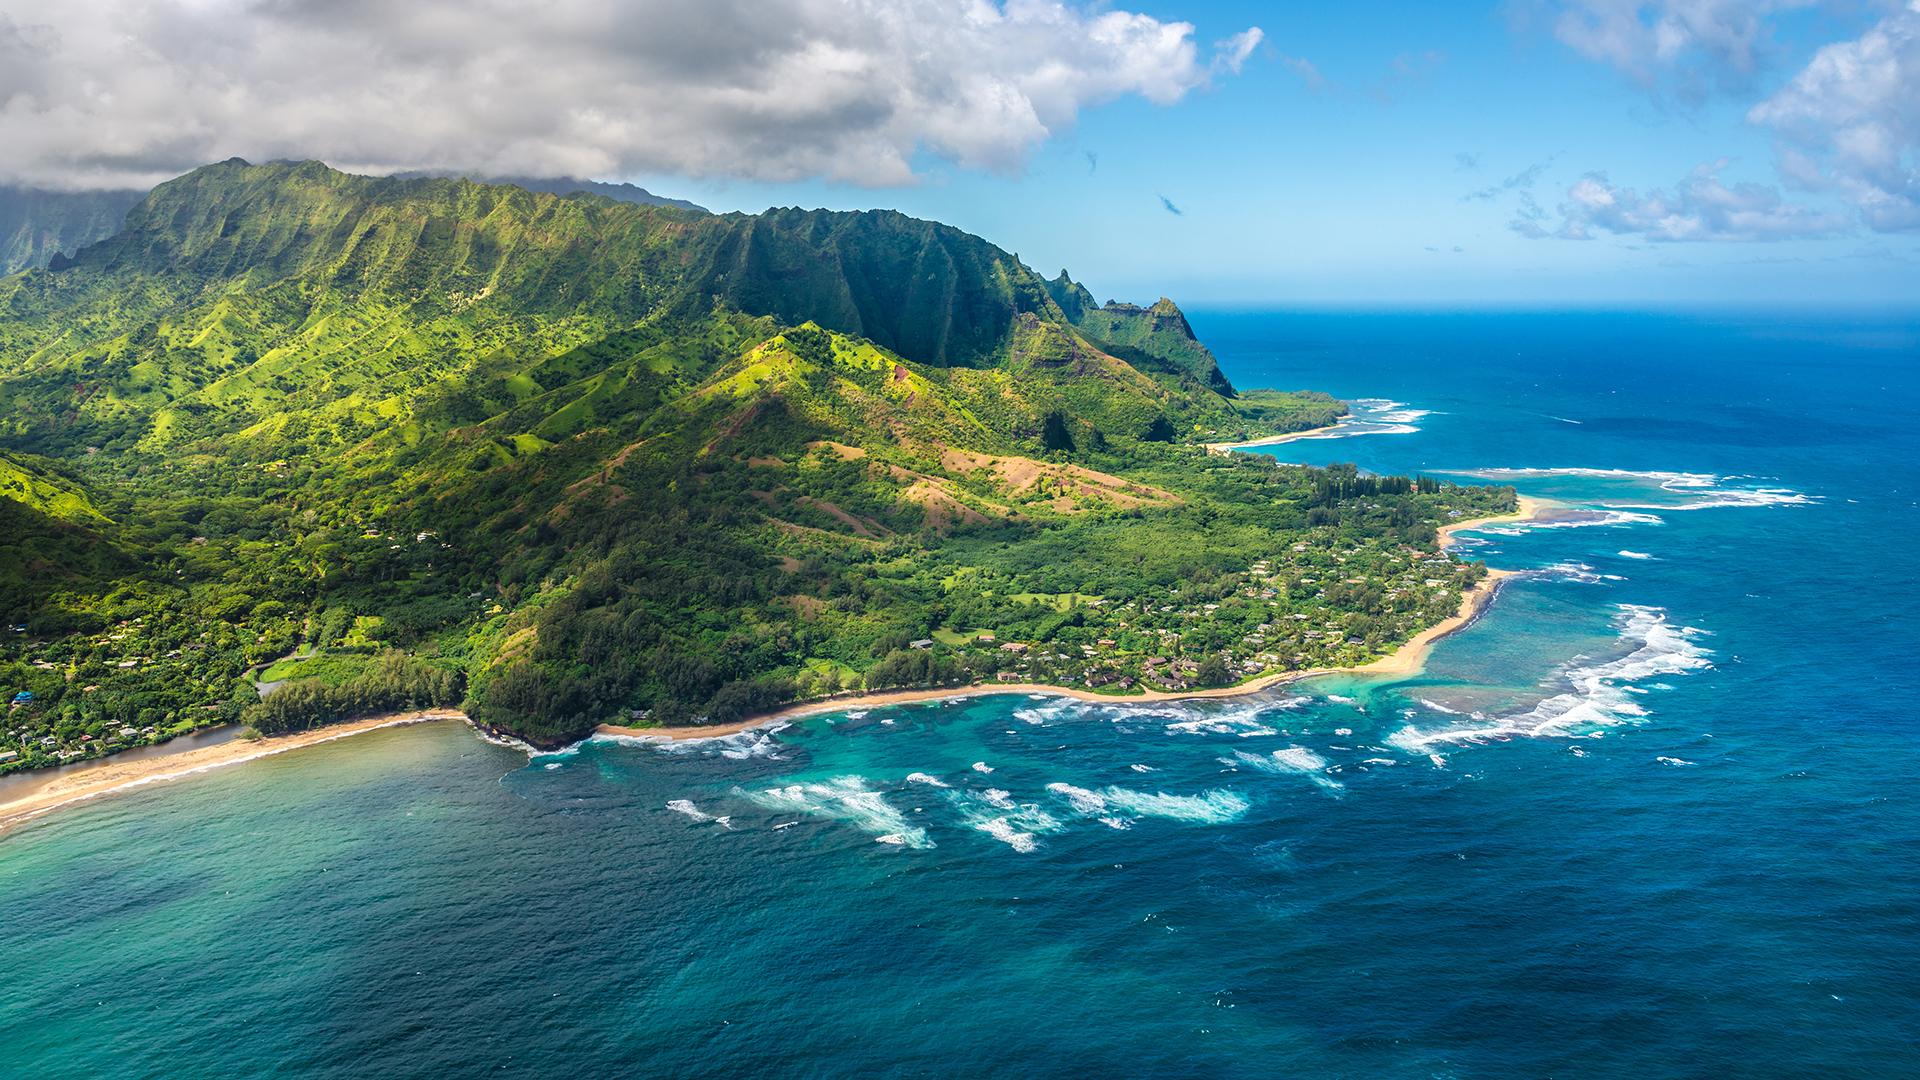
[0,709,467,836]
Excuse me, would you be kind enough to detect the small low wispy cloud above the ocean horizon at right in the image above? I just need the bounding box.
[1513,161,1847,242]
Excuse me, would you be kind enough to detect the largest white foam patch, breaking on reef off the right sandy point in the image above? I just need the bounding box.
[1386,603,1713,753]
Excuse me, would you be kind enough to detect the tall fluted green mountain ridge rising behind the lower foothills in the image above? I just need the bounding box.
[0,160,1231,452]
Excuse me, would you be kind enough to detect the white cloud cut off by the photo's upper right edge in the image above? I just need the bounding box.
[1747,0,1920,233]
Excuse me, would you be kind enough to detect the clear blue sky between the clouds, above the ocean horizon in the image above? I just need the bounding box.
[636,2,1920,306]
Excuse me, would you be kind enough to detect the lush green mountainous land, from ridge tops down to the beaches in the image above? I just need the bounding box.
[0,161,1511,769]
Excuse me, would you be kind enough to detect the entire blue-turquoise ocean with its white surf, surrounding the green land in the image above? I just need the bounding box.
[0,311,1920,1078]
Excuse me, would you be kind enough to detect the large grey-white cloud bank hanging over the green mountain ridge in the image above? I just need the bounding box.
[0,0,1261,186]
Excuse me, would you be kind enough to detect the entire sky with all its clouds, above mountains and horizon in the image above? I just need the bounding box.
[15,0,1920,306]
